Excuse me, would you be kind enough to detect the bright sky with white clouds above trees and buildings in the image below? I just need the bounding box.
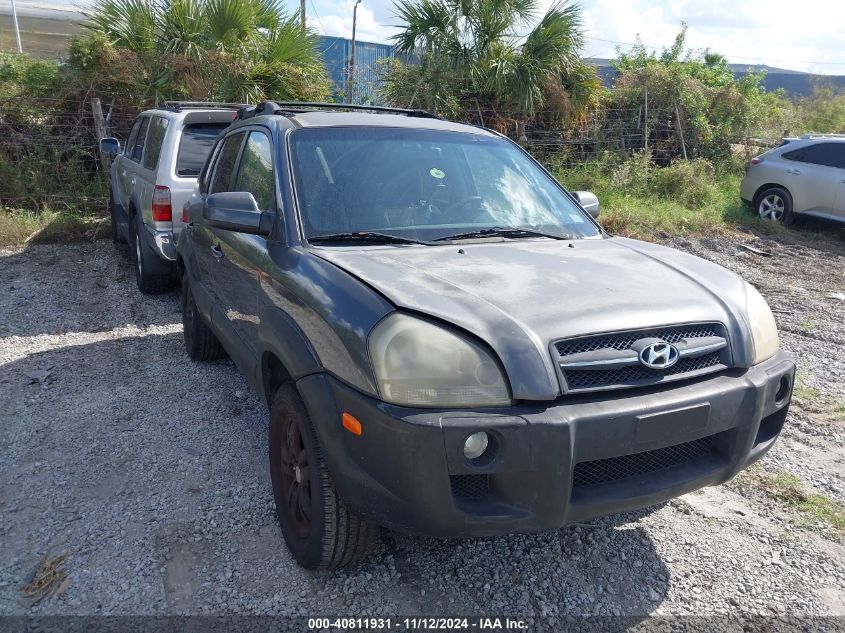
[9,0,845,75]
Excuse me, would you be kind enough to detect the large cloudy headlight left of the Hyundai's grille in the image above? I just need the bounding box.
[369,313,511,407]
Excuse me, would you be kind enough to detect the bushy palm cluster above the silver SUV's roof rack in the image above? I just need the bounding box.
[82,0,329,101]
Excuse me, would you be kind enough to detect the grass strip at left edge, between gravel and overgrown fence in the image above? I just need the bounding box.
[0,207,110,248]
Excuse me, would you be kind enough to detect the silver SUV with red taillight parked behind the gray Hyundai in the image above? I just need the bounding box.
[100,101,240,294]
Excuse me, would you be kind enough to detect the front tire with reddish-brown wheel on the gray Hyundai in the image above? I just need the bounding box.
[269,383,379,569]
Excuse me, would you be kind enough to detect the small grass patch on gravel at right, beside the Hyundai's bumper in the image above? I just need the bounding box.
[747,468,845,533]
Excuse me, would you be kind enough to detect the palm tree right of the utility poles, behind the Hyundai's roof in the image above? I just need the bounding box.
[395,0,584,132]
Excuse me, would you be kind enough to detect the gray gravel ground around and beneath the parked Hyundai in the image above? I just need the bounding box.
[0,230,845,625]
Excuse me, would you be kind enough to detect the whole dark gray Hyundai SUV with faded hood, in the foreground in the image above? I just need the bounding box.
[177,103,795,569]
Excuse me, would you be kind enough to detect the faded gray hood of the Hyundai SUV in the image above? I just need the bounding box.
[313,238,747,399]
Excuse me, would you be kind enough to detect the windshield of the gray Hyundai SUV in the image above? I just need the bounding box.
[291,127,599,241]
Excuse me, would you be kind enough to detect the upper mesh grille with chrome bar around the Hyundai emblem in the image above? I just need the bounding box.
[552,323,731,393]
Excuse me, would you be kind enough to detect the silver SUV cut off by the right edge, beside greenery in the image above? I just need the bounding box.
[740,134,845,224]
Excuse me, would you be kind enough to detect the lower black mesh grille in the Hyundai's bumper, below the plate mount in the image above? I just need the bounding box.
[572,434,721,488]
